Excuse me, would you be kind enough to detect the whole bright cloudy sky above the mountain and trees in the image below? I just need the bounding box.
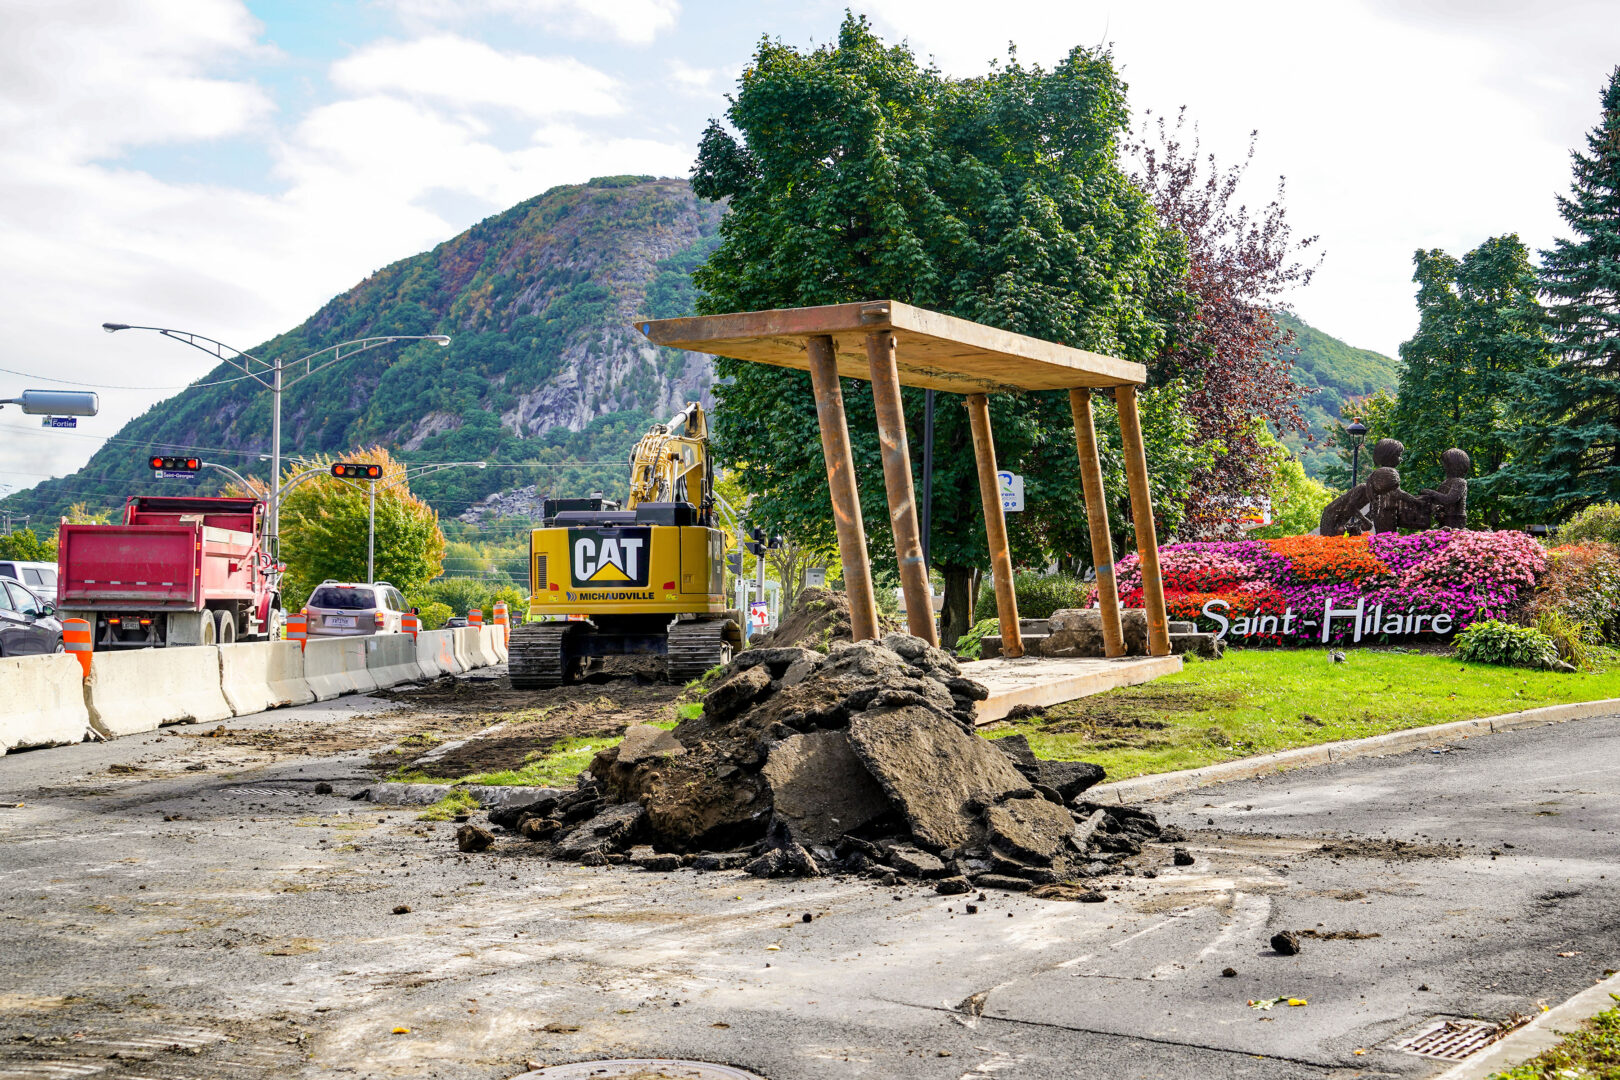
[0,0,1620,494]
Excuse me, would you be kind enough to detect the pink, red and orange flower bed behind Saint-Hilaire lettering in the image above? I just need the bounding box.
[1116,529,1547,644]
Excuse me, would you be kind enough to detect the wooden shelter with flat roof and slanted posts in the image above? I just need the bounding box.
[637,300,1170,657]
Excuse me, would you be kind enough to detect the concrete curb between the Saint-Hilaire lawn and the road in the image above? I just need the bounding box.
[1085,698,1620,803]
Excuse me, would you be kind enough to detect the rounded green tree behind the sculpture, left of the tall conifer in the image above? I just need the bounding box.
[1393,233,1549,528]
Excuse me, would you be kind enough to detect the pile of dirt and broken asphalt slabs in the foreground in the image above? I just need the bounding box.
[473,633,1160,899]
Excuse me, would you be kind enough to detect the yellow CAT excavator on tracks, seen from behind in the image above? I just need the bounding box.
[507,402,742,690]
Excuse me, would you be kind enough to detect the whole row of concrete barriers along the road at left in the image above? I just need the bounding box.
[0,625,505,755]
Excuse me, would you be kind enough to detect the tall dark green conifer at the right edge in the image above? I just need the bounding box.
[1513,66,1620,518]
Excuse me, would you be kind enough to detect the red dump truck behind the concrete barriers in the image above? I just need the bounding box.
[57,495,282,649]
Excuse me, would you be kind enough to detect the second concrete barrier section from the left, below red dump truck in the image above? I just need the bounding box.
[84,644,232,738]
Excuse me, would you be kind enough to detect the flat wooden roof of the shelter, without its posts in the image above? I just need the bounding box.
[635,300,1147,393]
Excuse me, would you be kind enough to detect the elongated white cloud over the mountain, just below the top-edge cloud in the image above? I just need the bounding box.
[332,34,624,117]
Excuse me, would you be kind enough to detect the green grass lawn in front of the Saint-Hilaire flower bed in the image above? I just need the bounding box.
[987,649,1620,780]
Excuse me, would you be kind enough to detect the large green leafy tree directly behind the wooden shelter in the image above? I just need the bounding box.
[692,16,1202,640]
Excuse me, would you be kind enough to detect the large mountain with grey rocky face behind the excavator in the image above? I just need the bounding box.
[3,176,724,518]
